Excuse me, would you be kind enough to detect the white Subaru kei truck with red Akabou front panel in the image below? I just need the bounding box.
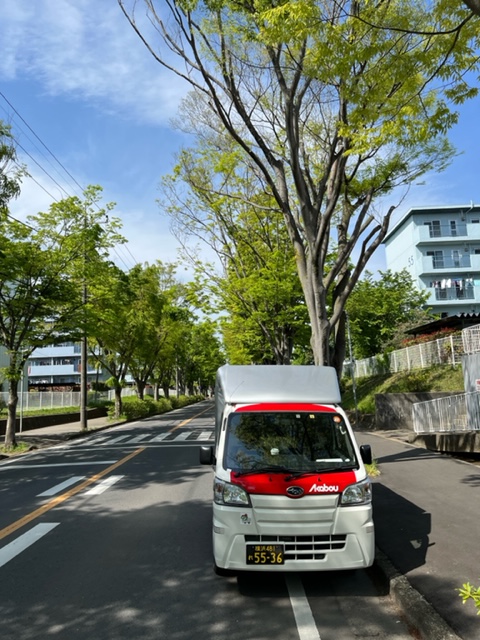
[200,365,375,575]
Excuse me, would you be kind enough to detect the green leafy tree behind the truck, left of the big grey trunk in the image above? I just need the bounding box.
[163,142,309,364]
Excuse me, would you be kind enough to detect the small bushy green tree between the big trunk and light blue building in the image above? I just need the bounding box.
[347,269,432,358]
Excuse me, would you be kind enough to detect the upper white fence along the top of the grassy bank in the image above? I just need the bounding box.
[352,327,464,378]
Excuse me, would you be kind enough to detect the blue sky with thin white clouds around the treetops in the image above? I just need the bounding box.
[0,0,480,273]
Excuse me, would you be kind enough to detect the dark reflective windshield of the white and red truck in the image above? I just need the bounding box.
[224,411,357,472]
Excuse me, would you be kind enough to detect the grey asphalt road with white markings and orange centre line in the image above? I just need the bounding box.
[0,402,418,640]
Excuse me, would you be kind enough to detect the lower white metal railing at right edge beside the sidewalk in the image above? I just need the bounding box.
[412,391,480,434]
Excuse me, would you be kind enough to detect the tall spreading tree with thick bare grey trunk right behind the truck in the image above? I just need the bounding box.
[118,0,478,372]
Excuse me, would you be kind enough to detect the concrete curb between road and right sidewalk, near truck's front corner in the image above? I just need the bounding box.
[372,547,462,640]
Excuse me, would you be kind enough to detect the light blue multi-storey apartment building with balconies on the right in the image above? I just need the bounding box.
[384,203,480,317]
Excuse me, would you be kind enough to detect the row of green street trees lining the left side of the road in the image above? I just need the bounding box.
[0,123,223,448]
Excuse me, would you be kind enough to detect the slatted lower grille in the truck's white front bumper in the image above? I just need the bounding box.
[245,535,347,561]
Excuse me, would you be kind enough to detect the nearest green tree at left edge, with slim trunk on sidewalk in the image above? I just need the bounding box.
[0,187,124,448]
